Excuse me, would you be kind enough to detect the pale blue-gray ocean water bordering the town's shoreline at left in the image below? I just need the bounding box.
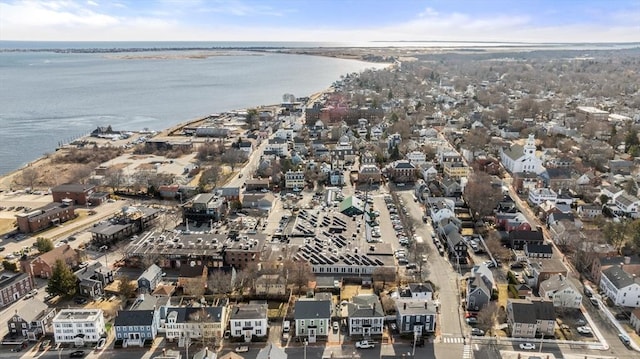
[0,47,385,174]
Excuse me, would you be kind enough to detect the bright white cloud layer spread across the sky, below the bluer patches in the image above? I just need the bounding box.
[0,0,640,42]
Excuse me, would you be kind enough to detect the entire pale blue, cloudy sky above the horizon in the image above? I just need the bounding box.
[0,0,640,43]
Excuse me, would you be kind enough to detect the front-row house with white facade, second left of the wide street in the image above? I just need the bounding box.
[347,294,385,338]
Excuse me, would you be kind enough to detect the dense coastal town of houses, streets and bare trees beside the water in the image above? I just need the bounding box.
[0,50,640,359]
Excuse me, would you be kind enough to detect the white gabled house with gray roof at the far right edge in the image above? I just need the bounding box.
[600,265,640,308]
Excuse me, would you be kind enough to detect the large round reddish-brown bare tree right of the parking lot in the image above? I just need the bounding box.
[464,172,502,218]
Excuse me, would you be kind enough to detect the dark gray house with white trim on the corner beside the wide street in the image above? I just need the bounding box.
[396,299,437,336]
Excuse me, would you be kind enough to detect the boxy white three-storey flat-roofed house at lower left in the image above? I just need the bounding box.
[52,309,105,346]
